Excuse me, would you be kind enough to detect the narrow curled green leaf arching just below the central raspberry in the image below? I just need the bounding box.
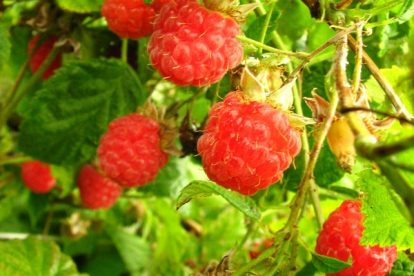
[177,181,260,221]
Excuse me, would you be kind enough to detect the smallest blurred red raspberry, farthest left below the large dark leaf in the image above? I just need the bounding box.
[21,161,56,193]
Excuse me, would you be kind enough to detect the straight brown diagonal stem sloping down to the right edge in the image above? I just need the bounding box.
[348,35,414,120]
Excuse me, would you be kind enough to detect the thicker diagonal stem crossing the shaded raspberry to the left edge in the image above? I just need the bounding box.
[0,47,60,129]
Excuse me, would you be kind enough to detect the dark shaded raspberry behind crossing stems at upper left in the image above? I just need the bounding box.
[28,35,62,80]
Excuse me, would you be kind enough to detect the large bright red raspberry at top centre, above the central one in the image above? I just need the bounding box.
[148,0,243,86]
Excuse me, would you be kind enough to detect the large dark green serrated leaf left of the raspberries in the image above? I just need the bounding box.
[18,59,144,165]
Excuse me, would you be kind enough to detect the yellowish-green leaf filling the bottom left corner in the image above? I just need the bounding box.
[0,237,80,276]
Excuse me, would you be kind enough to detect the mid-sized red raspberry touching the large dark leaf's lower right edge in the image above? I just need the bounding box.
[98,113,168,187]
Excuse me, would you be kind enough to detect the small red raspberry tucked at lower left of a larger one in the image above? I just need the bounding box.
[77,165,122,209]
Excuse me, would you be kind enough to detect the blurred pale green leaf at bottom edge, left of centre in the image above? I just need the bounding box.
[105,225,151,275]
